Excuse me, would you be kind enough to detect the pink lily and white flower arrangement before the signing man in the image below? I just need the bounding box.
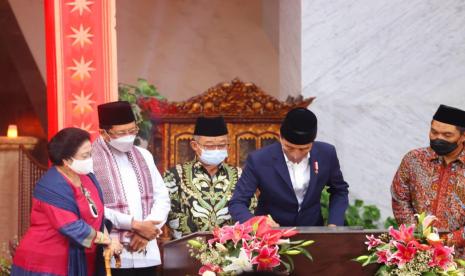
[188,216,313,276]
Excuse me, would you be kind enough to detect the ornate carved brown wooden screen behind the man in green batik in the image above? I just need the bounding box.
[151,79,314,170]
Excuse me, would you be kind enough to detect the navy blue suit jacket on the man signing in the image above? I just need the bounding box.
[228,142,349,226]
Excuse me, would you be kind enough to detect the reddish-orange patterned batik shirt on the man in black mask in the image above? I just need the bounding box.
[391,148,465,251]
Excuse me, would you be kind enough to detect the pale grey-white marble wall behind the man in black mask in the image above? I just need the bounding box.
[302,0,465,221]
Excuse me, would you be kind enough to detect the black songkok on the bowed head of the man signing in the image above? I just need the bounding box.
[281,107,317,145]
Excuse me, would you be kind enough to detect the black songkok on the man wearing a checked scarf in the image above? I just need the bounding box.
[97,101,136,128]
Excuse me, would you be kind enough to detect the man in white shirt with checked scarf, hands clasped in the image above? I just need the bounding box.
[92,101,170,276]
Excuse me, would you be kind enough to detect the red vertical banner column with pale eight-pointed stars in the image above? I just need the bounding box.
[45,0,118,138]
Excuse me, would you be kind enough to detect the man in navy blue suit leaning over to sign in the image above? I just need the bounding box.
[229,108,349,226]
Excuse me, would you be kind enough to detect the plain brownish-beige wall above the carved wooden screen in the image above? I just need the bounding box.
[116,0,279,100]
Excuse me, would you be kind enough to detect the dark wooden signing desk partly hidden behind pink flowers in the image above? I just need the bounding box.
[163,227,385,276]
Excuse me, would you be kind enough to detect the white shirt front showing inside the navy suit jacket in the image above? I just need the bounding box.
[283,152,310,210]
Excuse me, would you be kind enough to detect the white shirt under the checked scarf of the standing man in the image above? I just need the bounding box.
[105,146,170,268]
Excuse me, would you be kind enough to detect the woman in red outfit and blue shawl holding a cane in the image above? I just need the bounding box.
[11,128,121,275]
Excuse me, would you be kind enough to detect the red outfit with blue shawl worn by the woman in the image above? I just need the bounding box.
[12,167,104,275]
